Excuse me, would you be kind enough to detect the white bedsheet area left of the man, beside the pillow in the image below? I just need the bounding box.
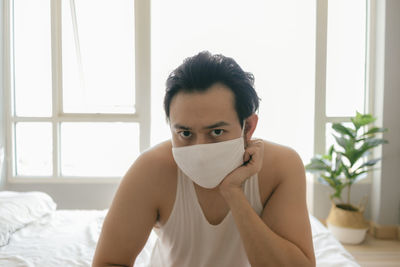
[0,210,107,267]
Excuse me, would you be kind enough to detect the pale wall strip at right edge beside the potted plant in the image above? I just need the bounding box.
[371,0,400,224]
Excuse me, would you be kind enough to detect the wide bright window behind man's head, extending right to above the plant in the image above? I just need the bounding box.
[151,0,368,169]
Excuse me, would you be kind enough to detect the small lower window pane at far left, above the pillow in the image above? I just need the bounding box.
[15,122,53,176]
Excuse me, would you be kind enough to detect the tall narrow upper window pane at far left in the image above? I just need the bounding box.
[13,0,52,116]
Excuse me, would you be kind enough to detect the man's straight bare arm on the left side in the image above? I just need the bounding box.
[92,154,158,267]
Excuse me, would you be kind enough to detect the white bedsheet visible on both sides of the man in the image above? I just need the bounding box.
[0,210,359,267]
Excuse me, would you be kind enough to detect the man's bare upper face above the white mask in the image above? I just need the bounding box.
[170,83,242,147]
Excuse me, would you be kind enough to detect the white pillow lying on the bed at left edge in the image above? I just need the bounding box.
[0,191,57,246]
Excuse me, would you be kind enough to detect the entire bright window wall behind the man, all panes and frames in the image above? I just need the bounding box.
[5,0,371,182]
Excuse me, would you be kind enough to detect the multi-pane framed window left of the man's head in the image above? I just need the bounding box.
[5,0,150,182]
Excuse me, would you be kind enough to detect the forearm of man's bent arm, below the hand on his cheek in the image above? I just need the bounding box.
[223,190,314,267]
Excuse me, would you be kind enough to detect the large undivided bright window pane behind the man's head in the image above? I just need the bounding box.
[151,0,316,163]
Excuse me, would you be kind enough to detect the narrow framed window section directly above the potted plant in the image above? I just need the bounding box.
[314,0,373,163]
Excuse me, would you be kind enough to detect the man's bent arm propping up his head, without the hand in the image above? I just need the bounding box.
[221,141,315,266]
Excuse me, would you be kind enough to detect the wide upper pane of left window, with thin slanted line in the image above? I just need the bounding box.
[62,0,135,113]
